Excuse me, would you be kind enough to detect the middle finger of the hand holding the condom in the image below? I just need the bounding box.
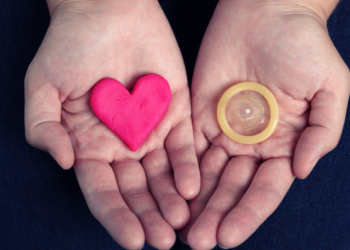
[187,156,259,249]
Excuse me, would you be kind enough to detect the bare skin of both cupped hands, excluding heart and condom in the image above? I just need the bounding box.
[25,0,349,249]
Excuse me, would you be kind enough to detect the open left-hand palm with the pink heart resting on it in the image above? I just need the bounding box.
[25,0,200,249]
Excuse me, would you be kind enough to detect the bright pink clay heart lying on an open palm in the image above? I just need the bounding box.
[90,74,171,151]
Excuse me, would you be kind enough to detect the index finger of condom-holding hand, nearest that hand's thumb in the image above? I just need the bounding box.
[217,158,294,248]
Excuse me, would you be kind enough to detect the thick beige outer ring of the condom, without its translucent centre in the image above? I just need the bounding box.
[217,82,279,144]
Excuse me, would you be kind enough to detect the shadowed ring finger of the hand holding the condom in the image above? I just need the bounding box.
[179,145,229,243]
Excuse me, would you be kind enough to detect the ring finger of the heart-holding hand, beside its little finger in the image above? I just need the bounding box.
[142,149,190,229]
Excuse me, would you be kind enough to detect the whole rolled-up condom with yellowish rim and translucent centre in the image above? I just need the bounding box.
[217,82,279,144]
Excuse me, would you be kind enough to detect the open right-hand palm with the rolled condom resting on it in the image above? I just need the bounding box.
[180,0,350,249]
